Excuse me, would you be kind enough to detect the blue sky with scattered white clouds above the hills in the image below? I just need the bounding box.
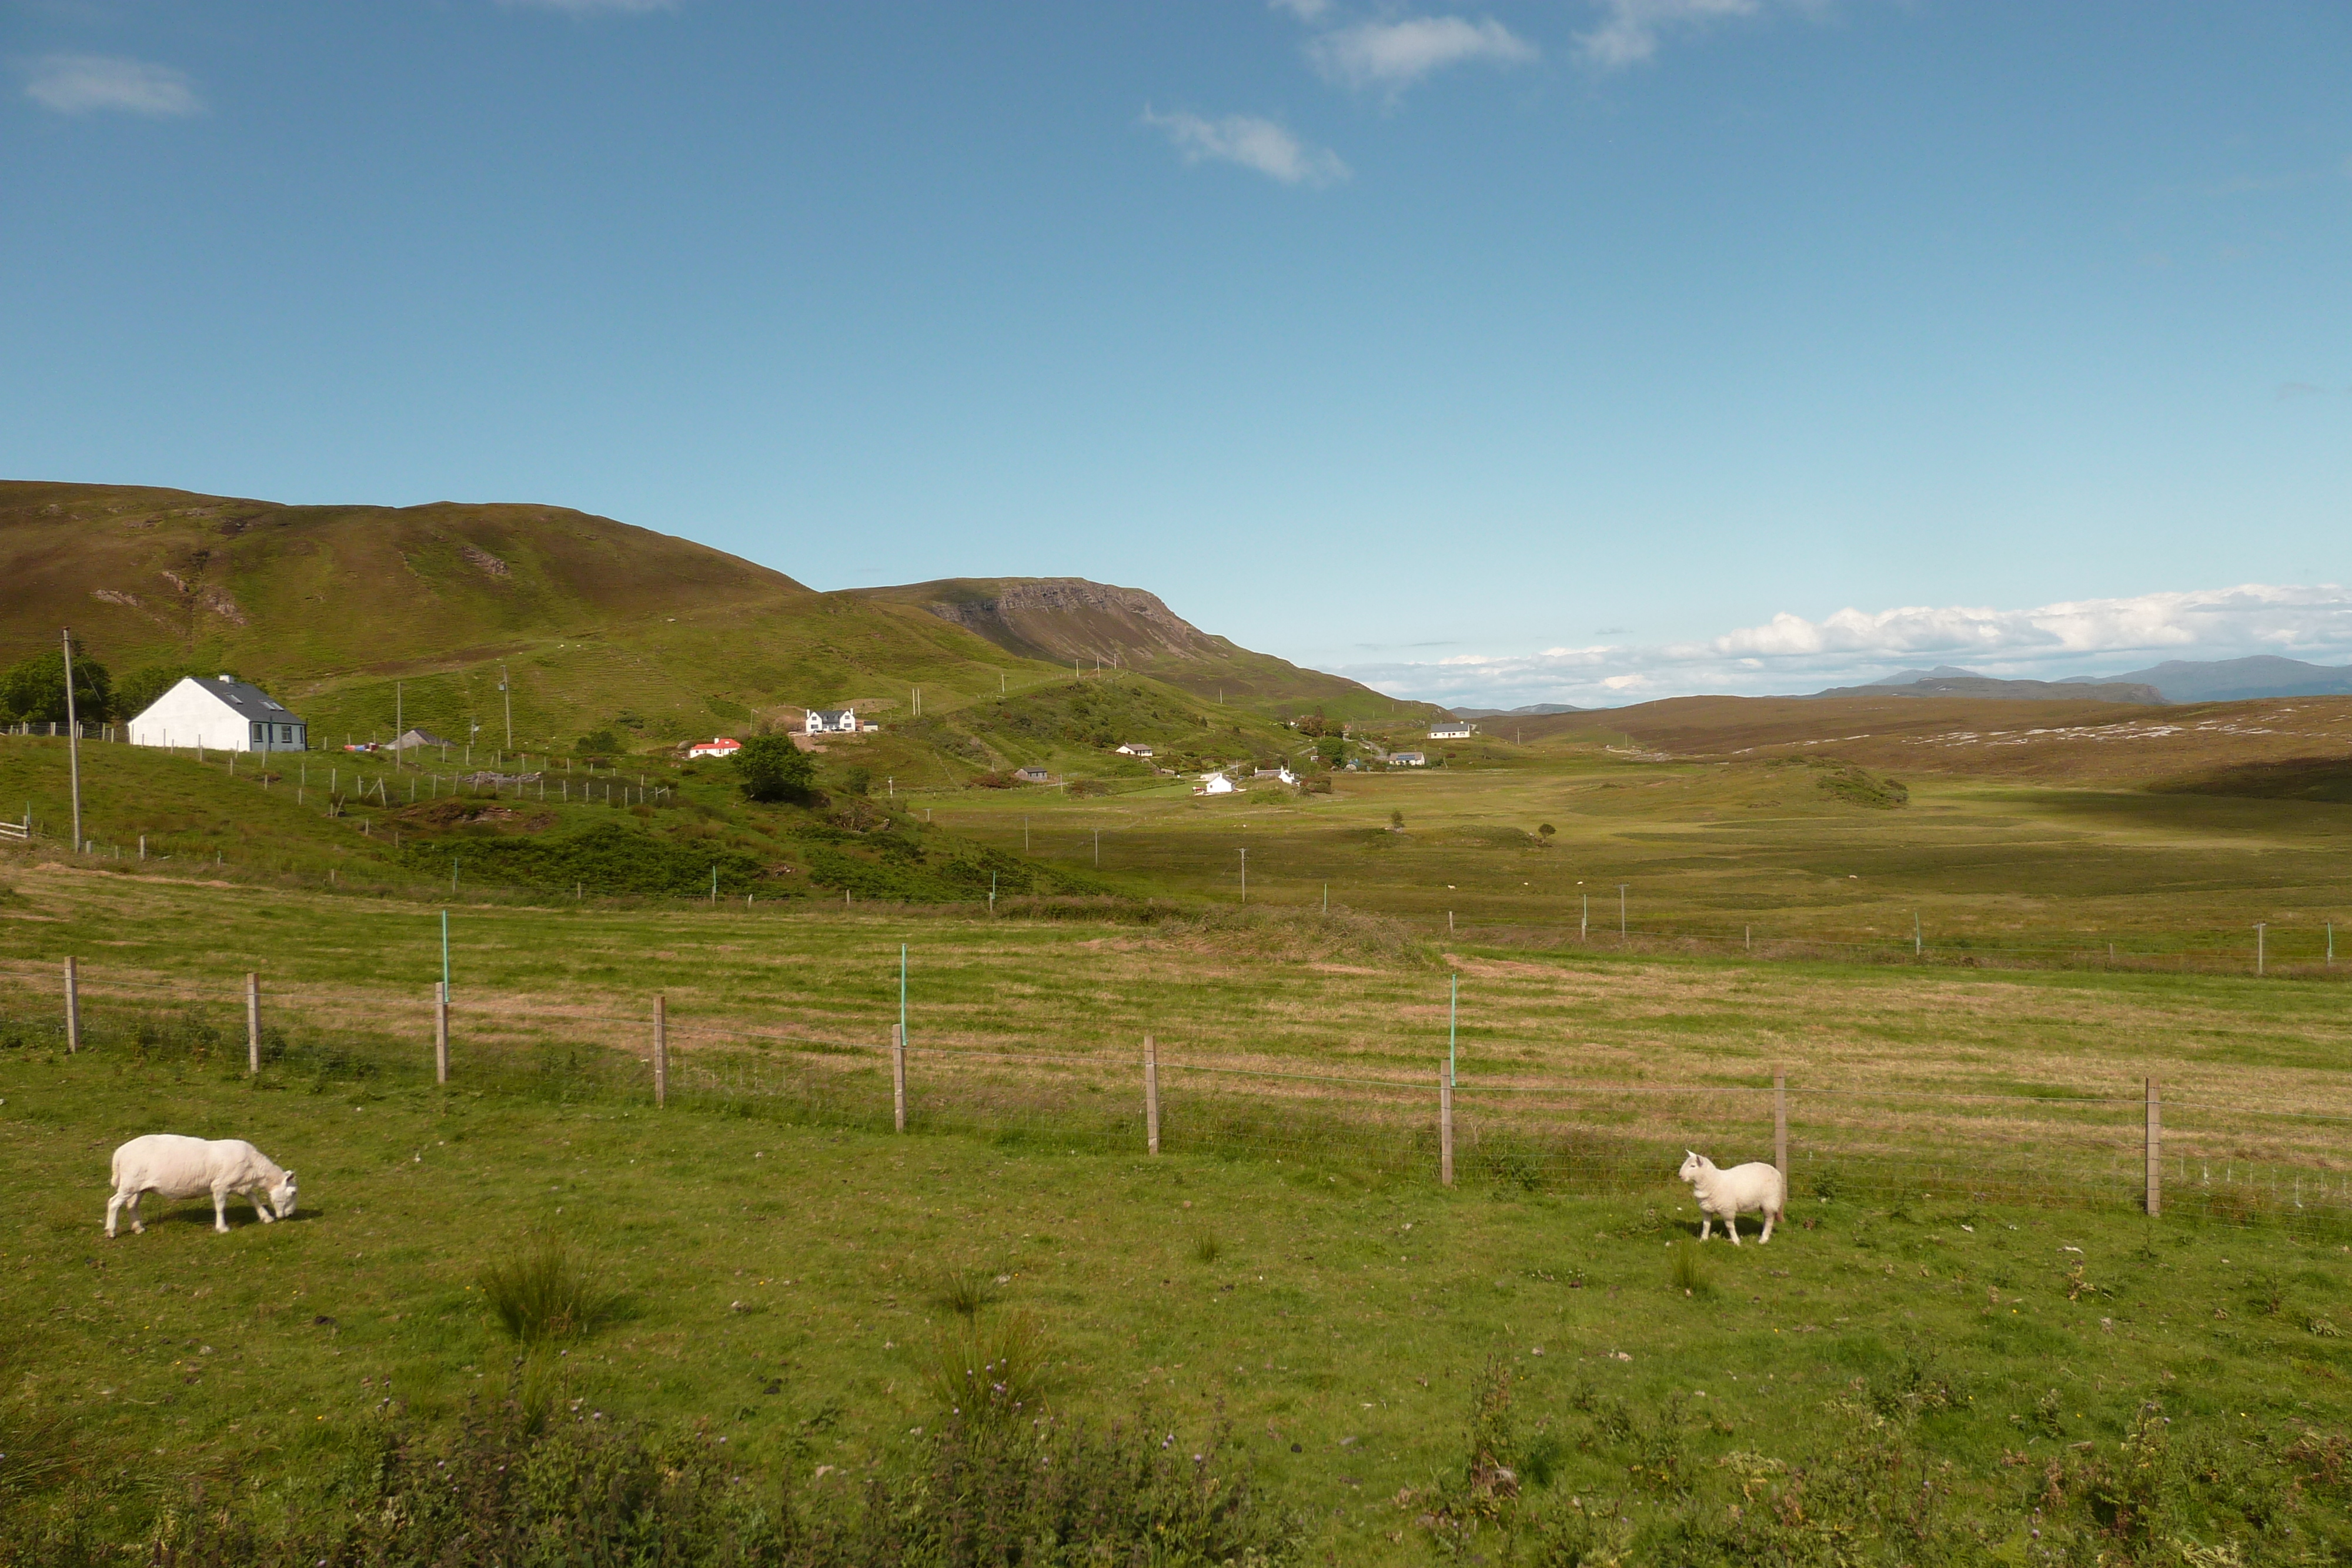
[0,0,2352,706]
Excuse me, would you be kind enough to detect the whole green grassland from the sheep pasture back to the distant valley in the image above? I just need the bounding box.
[14,741,2352,1563]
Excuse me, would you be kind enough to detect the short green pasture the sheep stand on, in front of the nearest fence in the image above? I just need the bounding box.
[0,1048,2352,1563]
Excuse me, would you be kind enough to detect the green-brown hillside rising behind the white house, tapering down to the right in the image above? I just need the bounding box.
[0,482,1421,766]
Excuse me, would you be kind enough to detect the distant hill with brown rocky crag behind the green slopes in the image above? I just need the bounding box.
[849,579,1439,720]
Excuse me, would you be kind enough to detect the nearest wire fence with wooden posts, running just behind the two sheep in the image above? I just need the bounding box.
[0,961,2352,1239]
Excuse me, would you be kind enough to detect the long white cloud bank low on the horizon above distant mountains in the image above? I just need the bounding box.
[1343,583,2352,708]
